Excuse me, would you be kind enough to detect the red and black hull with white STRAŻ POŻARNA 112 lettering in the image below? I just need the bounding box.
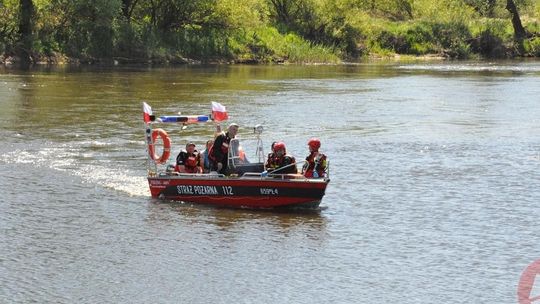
[148,176,329,209]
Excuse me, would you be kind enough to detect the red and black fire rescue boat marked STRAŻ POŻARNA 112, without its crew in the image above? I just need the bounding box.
[144,104,330,209]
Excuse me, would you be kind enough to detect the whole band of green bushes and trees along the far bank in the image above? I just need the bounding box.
[0,0,540,66]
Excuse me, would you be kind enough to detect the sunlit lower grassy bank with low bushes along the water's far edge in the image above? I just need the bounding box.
[0,22,540,66]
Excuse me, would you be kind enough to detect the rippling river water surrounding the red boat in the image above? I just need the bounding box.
[0,61,540,303]
